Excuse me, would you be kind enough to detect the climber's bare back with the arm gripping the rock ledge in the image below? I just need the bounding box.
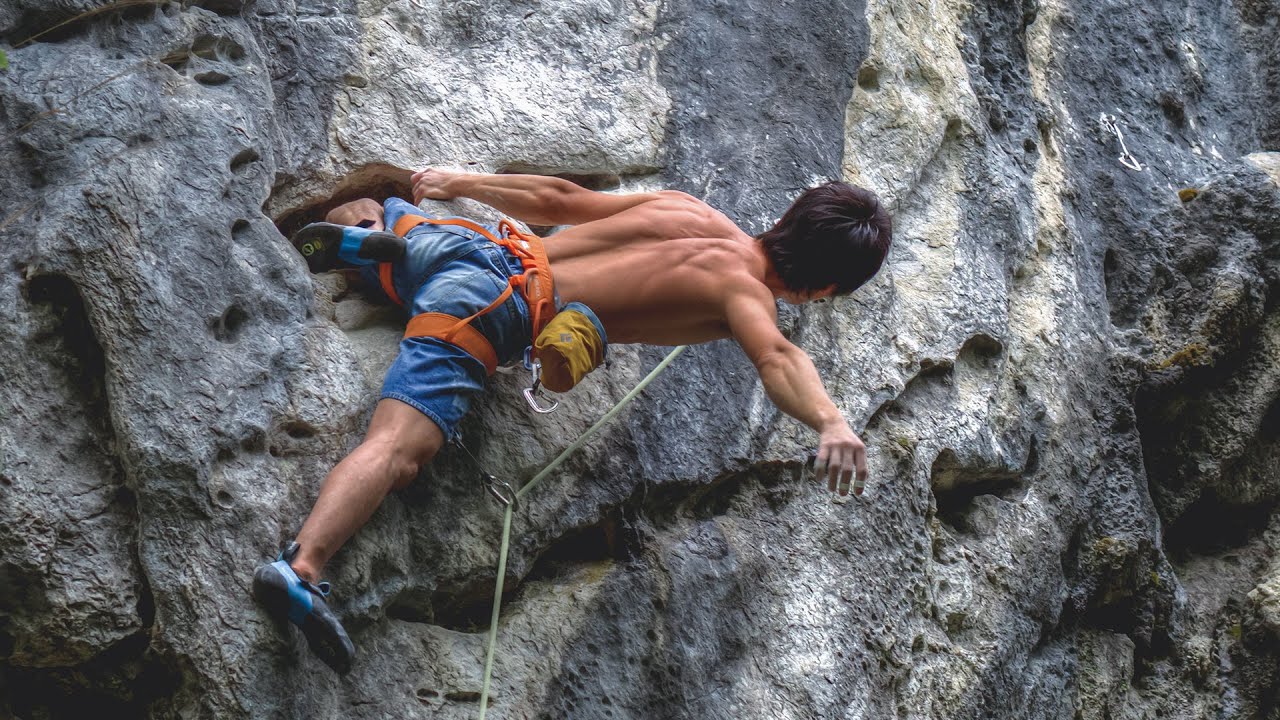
[412,168,781,348]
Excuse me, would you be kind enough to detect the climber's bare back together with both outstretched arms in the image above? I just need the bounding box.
[410,168,870,493]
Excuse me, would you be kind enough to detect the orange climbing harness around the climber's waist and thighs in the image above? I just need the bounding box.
[378,215,556,375]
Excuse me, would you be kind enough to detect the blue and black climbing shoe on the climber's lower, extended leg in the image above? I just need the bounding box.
[253,542,356,675]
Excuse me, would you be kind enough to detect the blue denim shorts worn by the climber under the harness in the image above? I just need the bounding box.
[361,197,532,439]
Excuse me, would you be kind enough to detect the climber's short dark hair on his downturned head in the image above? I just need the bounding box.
[759,182,893,295]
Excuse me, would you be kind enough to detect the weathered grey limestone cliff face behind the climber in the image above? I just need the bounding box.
[0,0,1280,720]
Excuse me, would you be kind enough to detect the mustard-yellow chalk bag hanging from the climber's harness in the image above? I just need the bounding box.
[534,302,609,392]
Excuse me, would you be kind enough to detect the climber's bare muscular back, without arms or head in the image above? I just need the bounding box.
[547,191,772,345]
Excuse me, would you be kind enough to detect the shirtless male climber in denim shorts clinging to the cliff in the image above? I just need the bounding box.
[253,169,892,673]
